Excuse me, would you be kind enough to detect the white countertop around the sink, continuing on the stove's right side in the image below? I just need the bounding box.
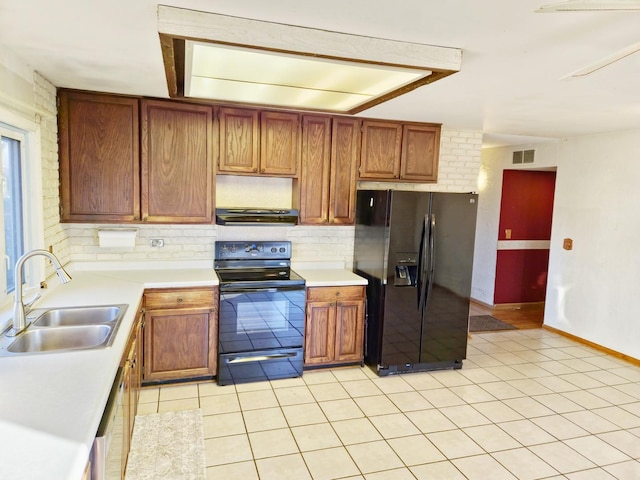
[0,263,367,480]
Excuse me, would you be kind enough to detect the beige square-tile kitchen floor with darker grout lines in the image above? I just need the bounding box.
[139,329,640,480]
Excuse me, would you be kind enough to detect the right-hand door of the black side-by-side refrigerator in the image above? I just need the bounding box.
[420,193,477,363]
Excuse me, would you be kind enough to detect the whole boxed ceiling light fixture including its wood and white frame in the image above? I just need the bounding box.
[158,5,462,114]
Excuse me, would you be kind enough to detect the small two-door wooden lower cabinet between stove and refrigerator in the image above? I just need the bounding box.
[304,286,365,366]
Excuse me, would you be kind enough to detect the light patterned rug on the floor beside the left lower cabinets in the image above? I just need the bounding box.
[125,409,207,480]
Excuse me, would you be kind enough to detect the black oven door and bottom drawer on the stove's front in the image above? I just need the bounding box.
[217,285,306,385]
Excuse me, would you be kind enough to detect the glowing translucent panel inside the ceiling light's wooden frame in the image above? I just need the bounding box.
[184,40,432,112]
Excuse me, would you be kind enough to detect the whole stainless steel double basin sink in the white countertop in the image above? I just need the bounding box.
[0,304,127,356]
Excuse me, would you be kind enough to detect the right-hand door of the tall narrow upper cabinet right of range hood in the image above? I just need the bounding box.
[329,117,360,225]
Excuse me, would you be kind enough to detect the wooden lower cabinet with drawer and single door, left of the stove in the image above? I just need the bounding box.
[143,288,218,383]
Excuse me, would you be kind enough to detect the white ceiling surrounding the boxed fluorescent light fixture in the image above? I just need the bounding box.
[0,0,640,146]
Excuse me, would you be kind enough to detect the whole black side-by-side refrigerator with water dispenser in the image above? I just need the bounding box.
[354,190,478,376]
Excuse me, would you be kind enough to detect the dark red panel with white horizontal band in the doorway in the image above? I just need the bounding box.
[494,170,556,305]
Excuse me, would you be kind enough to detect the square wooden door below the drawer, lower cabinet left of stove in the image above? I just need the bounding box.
[144,308,215,381]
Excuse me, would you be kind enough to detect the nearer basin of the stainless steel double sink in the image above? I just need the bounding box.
[7,325,113,353]
